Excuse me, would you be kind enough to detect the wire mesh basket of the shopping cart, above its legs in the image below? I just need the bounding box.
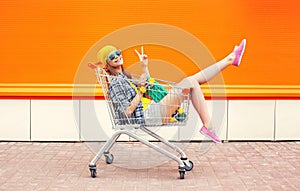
[95,67,190,128]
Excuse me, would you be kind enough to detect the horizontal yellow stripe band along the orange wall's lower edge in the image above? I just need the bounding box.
[0,84,300,98]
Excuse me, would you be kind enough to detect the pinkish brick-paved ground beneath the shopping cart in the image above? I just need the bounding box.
[0,142,300,191]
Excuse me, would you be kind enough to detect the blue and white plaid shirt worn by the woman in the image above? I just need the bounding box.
[109,74,145,125]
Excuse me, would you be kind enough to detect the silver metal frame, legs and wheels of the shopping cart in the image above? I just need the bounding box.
[88,64,193,179]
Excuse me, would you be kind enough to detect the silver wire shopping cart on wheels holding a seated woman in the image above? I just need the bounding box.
[88,64,193,179]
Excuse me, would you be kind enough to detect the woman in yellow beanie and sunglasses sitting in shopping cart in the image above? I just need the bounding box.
[97,39,246,143]
